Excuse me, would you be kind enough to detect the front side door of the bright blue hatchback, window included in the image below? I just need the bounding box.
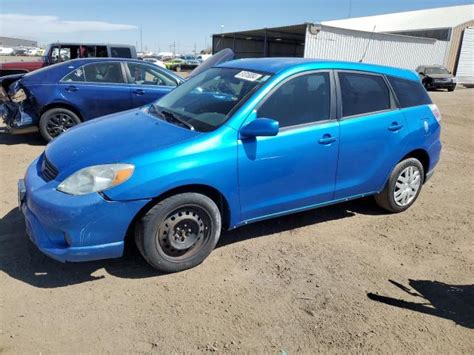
[238,71,339,221]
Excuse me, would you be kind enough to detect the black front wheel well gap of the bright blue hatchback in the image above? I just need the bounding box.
[125,184,230,250]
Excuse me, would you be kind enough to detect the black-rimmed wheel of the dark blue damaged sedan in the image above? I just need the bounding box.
[39,107,81,142]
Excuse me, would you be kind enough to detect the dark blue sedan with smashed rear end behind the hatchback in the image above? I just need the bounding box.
[0,58,184,141]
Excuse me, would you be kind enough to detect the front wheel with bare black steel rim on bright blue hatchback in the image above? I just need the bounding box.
[135,193,222,273]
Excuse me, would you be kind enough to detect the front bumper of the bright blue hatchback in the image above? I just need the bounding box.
[19,158,149,262]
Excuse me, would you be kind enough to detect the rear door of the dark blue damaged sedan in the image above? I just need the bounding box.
[60,61,132,120]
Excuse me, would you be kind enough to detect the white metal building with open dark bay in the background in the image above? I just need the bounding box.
[213,5,474,80]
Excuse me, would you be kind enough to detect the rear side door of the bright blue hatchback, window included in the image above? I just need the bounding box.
[335,71,409,199]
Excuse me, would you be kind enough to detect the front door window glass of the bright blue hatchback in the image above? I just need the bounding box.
[258,72,331,127]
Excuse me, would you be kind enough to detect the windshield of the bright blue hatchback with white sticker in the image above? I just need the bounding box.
[149,68,270,132]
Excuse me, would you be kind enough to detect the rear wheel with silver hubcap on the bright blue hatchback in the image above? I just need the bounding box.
[375,158,425,213]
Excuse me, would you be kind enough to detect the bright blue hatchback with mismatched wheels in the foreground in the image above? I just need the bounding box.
[19,58,441,272]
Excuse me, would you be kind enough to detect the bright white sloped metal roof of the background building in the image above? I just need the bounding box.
[322,5,474,32]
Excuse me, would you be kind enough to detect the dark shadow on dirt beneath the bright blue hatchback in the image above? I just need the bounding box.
[0,199,384,288]
